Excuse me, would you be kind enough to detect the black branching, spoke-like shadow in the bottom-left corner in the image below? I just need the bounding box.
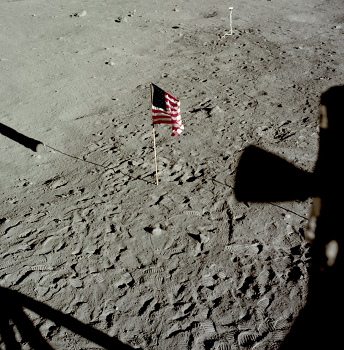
[0,287,137,350]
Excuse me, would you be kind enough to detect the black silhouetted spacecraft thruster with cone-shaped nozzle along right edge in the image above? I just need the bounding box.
[234,85,344,350]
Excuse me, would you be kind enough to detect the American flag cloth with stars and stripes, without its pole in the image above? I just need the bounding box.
[152,84,184,136]
